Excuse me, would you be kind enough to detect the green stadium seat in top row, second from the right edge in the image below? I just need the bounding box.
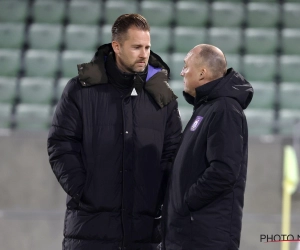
[247,2,280,28]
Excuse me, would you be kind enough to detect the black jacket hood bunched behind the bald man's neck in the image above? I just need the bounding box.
[184,68,254,109]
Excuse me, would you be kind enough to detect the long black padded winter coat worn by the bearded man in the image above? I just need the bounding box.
[48,45,181,250]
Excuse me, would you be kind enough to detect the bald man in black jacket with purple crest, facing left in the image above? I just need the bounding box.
[162,44,253,250]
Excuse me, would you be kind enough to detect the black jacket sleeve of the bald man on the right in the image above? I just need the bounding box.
[185,105,243,210]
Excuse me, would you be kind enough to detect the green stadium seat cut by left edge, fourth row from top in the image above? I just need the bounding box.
[0,77,17,105]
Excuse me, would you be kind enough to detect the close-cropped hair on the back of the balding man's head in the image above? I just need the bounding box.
[199,44,227,79]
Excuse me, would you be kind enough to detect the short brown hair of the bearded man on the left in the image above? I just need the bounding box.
[111,14,150,42]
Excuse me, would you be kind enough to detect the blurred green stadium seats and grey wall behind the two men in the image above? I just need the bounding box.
[0,0,300,250]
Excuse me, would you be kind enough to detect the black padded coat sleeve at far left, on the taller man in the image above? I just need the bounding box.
[48,79,86,201]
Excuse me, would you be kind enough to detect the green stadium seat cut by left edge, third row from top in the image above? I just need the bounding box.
[0,49,21,76]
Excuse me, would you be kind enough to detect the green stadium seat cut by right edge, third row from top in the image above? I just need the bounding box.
[280,55,300,82]
